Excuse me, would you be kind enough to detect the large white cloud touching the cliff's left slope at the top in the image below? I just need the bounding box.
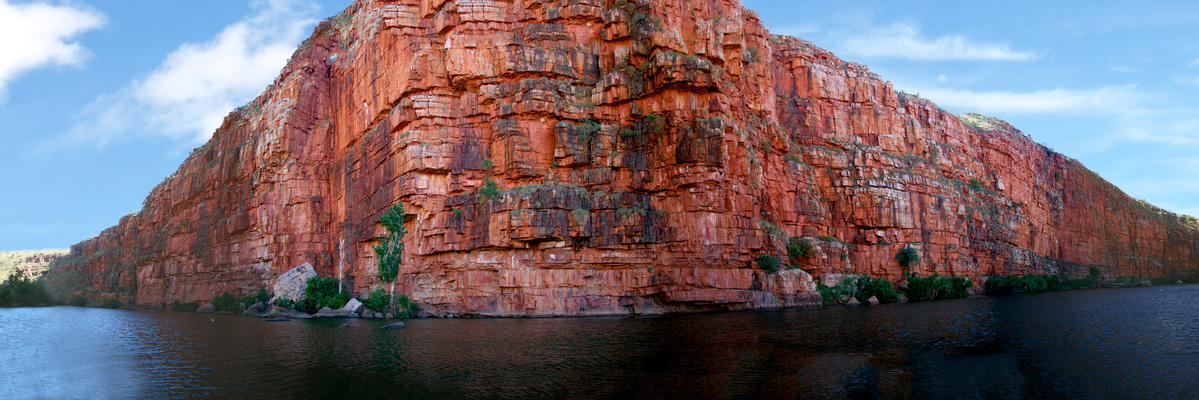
[71,0,319,145]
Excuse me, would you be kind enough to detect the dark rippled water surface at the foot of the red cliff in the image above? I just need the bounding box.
[0,285,1199,399]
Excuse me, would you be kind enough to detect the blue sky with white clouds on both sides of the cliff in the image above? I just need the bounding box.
[0,0,1199,250]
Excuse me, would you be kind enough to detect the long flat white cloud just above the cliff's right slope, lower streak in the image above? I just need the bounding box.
[917,85,1145,113]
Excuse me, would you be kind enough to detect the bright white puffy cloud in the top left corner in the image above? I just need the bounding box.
[0,0,104,101]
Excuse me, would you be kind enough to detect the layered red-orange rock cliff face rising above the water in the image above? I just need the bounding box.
[48,0,1199,316]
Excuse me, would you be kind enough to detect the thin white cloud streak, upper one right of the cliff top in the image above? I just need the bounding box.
[843,24,1037,61]
